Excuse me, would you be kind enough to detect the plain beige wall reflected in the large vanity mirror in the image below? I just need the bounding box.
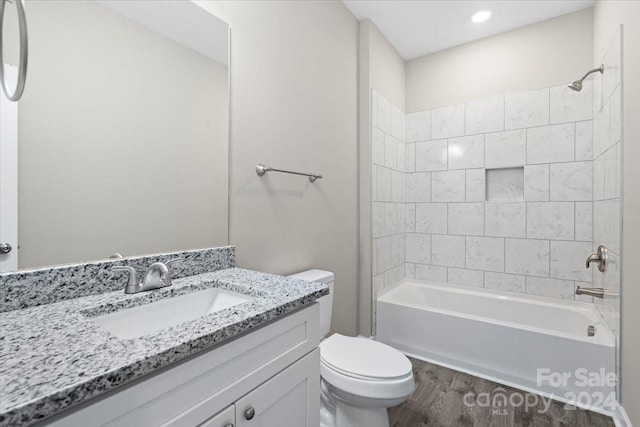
[9,1,228,268]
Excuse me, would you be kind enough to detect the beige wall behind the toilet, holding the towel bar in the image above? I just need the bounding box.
[202,1,358,335]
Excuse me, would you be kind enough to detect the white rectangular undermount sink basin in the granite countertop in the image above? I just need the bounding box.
[91,288,253,339]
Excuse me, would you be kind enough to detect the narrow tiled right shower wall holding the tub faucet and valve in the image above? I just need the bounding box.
[593,27,622,342]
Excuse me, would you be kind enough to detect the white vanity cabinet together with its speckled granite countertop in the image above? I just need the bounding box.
[0,254,328,427]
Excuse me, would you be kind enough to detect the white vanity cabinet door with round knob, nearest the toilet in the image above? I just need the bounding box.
[236,349,320,427]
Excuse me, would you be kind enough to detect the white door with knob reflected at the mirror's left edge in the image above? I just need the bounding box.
[0,63,18,273]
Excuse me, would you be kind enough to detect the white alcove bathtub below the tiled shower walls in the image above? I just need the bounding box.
[376,279,615,412]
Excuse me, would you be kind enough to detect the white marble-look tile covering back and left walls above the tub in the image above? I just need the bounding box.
[372,82,593,299]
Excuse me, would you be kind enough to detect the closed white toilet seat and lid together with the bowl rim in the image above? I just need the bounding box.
[320,334,415,400]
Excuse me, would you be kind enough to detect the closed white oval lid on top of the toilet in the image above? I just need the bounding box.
[320,334,411,380]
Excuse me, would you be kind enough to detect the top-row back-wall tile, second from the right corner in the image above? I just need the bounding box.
[504,88,549,129]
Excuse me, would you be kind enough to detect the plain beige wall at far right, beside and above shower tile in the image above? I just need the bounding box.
[593,0,640,425]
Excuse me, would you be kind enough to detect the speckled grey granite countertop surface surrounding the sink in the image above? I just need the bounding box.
[0,268,329,426]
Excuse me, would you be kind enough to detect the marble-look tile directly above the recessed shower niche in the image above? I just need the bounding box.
[484,129,527,168]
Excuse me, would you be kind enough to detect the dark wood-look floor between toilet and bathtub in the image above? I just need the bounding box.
[389,359,614,427]
